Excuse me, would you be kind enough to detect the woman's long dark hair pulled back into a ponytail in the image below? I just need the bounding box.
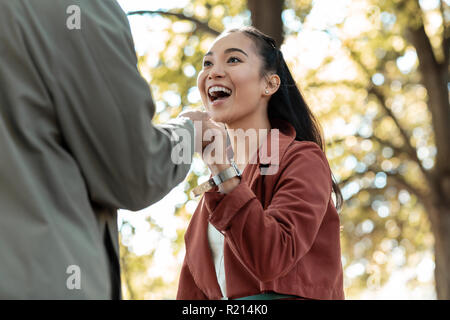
[224,27,343,209]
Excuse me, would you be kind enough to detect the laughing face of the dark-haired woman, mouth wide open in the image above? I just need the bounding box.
[197,32,267,124]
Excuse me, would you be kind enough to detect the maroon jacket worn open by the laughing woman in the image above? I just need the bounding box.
[177,120,344,300]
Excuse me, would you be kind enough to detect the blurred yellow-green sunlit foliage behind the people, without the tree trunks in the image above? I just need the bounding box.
[121,0,443,298]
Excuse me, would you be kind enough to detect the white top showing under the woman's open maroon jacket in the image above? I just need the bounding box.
[208,222,227,299]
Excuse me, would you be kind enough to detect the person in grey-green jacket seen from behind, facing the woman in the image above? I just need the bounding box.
[0,0,193,299]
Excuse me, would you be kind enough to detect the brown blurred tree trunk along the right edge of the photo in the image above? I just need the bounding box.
[406,21,450,300]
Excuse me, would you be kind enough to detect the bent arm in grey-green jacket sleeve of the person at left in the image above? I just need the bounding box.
[50,1,194,210]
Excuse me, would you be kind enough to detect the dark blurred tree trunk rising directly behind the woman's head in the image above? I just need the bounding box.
[247,0,284,48]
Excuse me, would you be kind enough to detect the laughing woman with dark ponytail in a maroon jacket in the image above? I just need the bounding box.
[177,27,344,300]
